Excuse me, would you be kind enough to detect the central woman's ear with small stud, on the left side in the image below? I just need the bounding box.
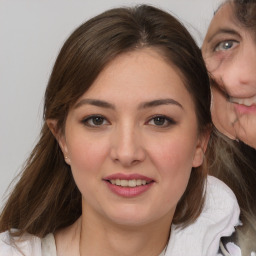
[46,119,70,164]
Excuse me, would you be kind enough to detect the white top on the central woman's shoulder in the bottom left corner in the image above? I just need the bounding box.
[0,231,56,256]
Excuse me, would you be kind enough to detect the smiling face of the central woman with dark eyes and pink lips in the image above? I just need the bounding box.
[59,49,204,228]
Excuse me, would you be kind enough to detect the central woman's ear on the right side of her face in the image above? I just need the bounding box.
[193,130,211,167]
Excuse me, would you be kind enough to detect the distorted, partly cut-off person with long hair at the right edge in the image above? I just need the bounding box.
[202,1,256,255]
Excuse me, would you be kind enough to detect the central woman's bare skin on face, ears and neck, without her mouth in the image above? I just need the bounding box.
[48,49,208,256]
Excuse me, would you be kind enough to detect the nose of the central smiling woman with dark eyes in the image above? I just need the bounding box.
[110,125,146,167]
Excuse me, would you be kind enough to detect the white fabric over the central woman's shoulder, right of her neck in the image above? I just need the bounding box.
[166,176,240,256]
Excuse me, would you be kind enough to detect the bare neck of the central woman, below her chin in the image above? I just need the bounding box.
[80,207,171,256]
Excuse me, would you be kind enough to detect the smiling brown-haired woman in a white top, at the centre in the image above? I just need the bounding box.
[0,5,239,256]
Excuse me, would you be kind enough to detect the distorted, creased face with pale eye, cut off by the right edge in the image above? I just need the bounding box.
[202,3,256,147]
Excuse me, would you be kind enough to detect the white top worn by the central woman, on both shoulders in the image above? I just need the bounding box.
[0,176,240,256]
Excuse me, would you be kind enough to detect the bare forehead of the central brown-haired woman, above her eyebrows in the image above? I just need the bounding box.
[79,49,192,103]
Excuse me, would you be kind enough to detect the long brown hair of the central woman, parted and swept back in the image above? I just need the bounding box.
[0,5,211,237]
